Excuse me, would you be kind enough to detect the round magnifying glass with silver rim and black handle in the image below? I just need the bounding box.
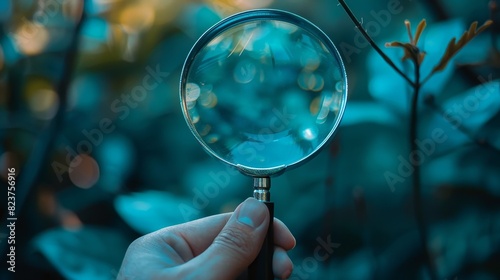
[180,9,347,279]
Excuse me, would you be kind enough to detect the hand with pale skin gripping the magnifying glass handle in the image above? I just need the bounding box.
[118,198,295,279]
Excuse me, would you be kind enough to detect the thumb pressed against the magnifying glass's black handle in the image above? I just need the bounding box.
[187,198,269,279]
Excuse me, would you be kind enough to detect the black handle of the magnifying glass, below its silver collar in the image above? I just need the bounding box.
[248,202,274,280]
